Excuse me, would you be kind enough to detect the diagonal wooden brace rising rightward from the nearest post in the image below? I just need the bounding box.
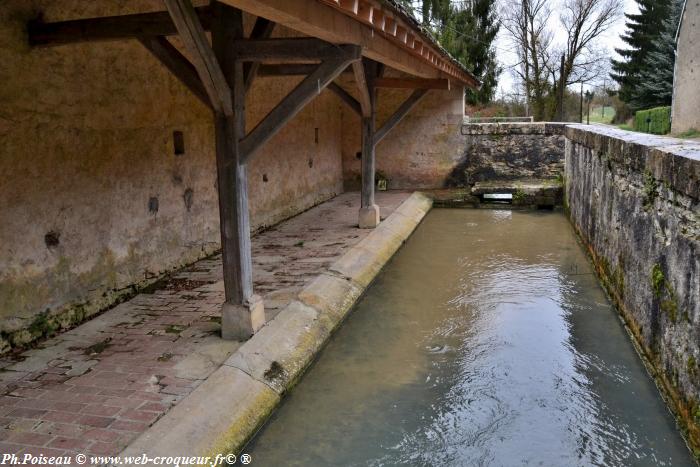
[240,46,361,162]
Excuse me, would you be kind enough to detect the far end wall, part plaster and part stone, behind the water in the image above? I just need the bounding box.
[343,119,564,190]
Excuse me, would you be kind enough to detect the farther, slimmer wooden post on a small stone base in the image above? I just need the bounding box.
[358,60,380,229]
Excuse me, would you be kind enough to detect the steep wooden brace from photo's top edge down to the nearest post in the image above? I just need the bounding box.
[163,0,233,116]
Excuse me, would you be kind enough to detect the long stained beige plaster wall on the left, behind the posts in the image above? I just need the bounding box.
[0,0,342,351]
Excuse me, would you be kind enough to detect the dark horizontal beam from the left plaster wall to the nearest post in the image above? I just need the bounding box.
[27,7,211,46]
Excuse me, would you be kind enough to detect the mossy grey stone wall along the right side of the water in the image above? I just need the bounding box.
[565,125,700,448]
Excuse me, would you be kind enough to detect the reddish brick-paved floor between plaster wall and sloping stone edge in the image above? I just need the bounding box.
[0,192,410,456]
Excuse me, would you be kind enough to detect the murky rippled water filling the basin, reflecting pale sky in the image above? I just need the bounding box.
[245,209,695,467]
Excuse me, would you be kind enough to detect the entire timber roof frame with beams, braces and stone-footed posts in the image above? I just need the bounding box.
[28,0,480,339]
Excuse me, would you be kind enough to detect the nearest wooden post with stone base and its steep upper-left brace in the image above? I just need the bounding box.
[164,0,265,340]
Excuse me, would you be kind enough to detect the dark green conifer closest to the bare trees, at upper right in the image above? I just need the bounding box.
[611,0,672,108]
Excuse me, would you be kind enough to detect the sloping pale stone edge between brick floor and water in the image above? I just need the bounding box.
[120,192,433,464]
